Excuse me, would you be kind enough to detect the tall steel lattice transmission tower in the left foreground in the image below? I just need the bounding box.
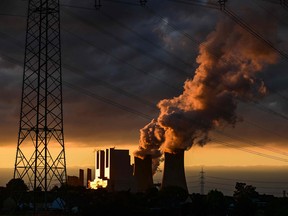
[14,0,66,191]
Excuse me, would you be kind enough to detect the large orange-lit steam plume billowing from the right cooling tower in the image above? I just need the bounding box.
[158,16,277,153]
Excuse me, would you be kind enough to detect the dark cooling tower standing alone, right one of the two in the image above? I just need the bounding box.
[161,150,188,191]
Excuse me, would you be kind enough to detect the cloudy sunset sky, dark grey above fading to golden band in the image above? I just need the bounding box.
[0,0,288,168]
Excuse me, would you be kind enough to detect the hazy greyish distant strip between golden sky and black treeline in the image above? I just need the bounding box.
[0,166,288,197]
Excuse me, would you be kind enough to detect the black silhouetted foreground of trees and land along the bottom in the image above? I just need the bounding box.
[0,181,288,216]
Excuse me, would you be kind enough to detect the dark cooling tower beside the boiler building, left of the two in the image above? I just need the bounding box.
[134,155,153,192]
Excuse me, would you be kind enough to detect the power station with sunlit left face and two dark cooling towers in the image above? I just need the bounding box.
[90,148,188,192]
